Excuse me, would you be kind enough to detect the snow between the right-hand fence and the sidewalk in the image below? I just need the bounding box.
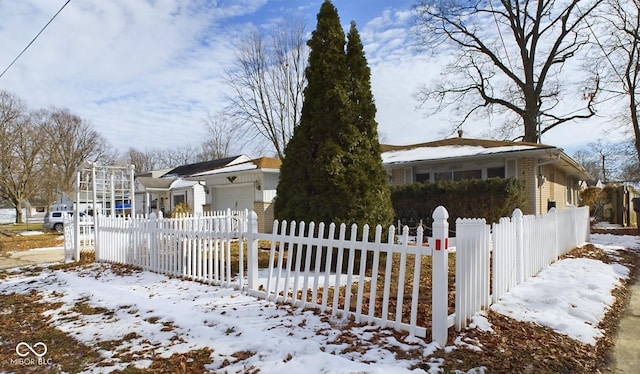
[491,234,640,344]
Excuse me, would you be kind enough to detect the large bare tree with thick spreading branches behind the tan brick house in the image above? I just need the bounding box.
[415,0,603,142]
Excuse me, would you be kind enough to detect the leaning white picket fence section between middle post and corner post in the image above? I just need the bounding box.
[246,207,451,344]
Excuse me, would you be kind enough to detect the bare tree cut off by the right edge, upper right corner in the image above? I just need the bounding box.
[589,0,640,161]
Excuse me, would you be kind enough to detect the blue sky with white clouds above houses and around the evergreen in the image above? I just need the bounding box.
[0,0,628,154]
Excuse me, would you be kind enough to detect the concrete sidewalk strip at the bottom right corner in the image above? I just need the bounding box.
[611,278,640,373]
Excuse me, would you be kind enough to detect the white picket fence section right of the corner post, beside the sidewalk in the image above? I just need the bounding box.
[455,207,590,329]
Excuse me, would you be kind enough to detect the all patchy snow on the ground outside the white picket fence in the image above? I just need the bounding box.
[0,234,640,373]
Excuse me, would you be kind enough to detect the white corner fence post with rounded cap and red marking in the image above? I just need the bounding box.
[431,205,449,347]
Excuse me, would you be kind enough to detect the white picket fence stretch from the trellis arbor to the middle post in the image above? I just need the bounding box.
[96,210,248,288]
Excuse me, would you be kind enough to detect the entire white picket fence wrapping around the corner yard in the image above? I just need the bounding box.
[70,206,589,346]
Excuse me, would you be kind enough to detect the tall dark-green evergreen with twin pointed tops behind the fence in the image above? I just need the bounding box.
[275,0,393,229]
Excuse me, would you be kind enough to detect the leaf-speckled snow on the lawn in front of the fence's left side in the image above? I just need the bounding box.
[0,265,437,373]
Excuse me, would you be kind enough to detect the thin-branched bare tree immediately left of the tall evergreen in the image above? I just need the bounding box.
[226,20,307,158]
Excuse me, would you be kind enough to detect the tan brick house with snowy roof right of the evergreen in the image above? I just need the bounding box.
[381,137,593,214]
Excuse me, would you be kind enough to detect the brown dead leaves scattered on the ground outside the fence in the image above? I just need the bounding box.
[0,237,640,373]
